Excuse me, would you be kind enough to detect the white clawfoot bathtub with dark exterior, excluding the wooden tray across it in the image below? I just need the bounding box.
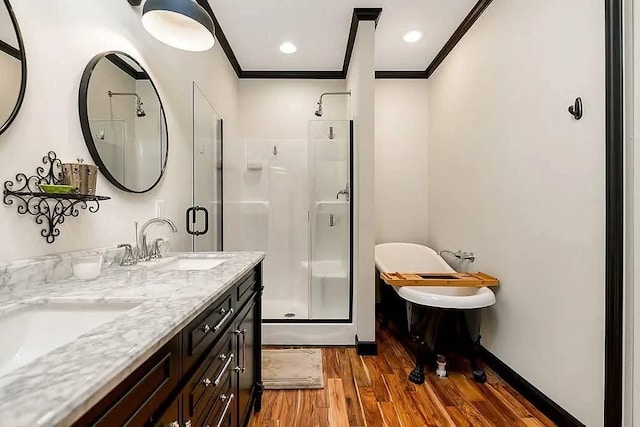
[375,243,496,384]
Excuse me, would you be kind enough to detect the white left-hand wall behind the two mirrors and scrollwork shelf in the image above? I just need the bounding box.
[0,0,237,261]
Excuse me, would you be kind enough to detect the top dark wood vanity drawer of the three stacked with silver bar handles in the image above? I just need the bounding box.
[182,292,234,373]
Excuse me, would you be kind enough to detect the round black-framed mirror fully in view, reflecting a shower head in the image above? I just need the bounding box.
[78,51,169,193]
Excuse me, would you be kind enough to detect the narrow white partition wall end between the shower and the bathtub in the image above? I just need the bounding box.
[347,21,376,342]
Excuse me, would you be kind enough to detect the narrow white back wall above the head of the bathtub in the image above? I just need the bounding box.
[375,79,429,244]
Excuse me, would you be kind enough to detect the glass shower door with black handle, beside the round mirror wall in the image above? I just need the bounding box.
[190,82,223,252]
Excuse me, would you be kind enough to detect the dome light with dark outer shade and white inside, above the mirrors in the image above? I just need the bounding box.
[142,0,215,52]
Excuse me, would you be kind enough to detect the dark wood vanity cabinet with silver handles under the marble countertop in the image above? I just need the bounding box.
[75,265,262,427]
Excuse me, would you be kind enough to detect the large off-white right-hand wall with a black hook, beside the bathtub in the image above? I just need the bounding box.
[428,0,605,426]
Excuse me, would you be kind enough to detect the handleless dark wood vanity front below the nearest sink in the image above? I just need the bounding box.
[75,337,179,427]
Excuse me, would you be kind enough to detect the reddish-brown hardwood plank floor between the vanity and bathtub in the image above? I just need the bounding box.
[250,322,555,427]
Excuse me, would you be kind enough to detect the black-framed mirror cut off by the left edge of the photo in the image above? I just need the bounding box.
[0,0,27,133]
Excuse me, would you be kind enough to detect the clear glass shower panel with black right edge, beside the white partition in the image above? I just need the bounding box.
[308,120,353,320]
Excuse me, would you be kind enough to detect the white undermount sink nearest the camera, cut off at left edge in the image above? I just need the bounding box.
[0,302,139,376]
